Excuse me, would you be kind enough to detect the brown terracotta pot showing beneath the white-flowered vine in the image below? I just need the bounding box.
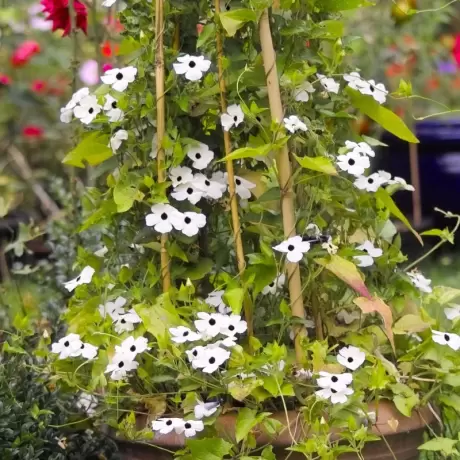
[117,401,434,460]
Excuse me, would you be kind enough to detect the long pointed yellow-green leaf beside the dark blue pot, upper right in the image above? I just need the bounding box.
[345,87,419,143]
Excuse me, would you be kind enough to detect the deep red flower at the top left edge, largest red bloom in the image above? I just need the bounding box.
[40,0,88,37]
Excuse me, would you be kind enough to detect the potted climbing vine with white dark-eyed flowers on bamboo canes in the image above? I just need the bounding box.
[47,0,460,460]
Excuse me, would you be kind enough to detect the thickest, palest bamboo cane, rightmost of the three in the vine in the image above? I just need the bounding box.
[259,9,306,364]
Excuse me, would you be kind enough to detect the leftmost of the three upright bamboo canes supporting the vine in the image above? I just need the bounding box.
[155,0,171,292]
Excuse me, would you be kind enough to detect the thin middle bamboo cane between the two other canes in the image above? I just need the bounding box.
[215,0,254,337]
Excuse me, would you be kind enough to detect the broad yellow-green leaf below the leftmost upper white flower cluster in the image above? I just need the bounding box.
[62,132,113,168]
